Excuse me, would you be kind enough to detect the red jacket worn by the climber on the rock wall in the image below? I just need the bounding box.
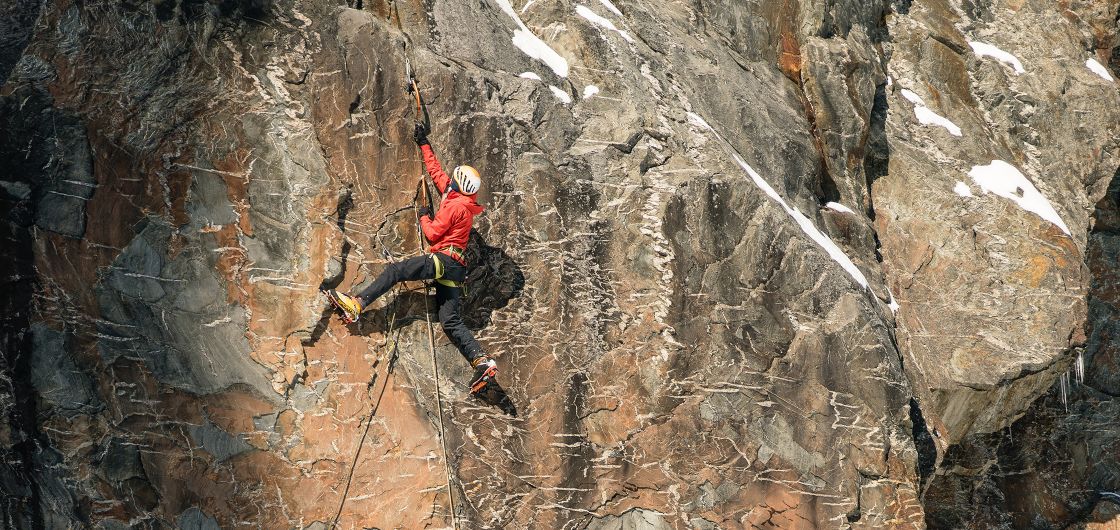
[420,145,484,264]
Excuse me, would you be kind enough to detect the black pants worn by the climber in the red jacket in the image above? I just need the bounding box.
[357,253,484,361]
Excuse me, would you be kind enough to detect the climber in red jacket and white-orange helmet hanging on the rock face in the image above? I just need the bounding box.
[327,123,497,393]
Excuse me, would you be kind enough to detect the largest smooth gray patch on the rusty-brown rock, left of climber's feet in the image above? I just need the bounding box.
[97,220,277,399]
